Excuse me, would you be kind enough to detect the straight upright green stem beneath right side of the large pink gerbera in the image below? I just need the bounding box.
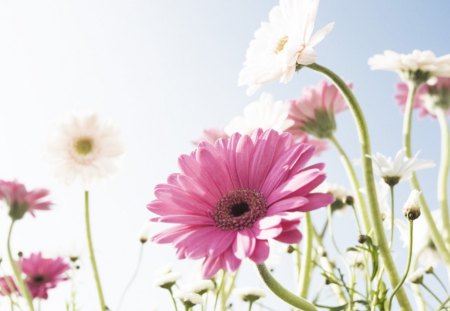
[299,213,314,297]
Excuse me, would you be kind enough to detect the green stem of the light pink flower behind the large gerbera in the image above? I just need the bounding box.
[329,135,371,232]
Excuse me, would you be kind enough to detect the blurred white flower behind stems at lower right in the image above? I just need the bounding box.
[395,210,444,267]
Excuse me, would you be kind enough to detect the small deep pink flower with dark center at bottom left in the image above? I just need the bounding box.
[21,252,70,299]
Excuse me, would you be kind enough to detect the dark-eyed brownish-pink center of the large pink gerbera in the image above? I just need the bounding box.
[213,189,267,230]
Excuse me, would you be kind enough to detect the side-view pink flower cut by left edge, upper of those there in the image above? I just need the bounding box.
[0,180,52,220]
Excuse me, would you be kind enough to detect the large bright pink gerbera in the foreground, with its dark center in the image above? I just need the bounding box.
[148,130,332,278]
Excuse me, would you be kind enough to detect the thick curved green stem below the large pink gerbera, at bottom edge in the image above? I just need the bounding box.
[257,264,317,311]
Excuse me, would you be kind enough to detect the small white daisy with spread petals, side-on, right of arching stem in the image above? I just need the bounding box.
[371,150,434,186]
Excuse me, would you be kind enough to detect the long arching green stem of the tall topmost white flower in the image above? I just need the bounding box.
[308,64,411,310]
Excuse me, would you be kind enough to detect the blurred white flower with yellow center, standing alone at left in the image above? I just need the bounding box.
[51,114,123,186]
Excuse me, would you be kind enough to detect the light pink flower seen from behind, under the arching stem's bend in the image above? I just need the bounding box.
[288,81,348,138]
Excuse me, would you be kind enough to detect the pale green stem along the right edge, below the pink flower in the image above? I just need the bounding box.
[436,108,450,247]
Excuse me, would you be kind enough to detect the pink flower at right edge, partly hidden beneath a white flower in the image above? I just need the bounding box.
[395,78,450,118]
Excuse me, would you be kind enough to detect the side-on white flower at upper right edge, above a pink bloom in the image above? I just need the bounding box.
[369,50,450,83]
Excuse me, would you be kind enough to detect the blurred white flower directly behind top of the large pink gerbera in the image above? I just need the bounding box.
[225,93,294,135]
